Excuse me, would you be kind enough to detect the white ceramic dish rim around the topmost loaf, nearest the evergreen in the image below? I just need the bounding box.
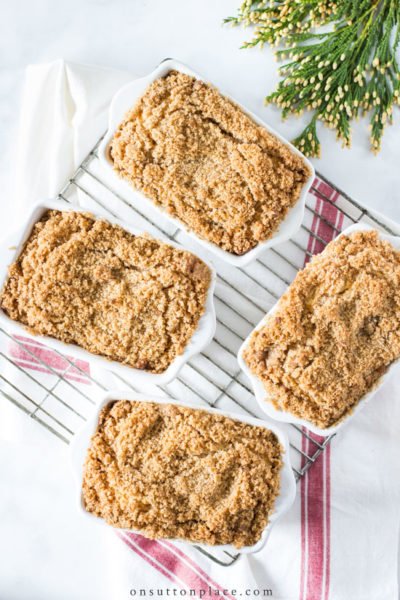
[99,58,315,267]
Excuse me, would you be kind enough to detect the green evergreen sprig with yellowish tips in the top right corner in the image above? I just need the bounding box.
[227,0,400,156]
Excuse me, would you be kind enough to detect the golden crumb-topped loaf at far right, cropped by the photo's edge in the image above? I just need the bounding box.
[244,231,400,429]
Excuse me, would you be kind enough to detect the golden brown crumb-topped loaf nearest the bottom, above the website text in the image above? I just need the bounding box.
[83,400,282,548]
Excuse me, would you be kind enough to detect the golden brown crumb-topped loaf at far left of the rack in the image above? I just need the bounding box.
[0,210,211,373]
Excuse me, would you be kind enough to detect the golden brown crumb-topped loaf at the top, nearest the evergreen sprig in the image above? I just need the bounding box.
[110,71,310,255]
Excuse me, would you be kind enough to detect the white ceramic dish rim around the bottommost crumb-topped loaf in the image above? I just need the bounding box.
[71,391,296,554]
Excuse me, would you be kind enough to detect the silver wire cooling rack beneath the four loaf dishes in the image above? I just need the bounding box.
[0,135,393,566]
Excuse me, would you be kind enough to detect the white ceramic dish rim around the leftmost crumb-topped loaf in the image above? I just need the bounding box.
[0,200,216,385]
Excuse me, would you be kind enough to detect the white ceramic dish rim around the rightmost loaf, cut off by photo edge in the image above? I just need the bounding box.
[238,224,400,437]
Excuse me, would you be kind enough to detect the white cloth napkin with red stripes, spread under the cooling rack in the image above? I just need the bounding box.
[3,60,400,600]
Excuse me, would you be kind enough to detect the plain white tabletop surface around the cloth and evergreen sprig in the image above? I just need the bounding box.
[0,0,400,600]
